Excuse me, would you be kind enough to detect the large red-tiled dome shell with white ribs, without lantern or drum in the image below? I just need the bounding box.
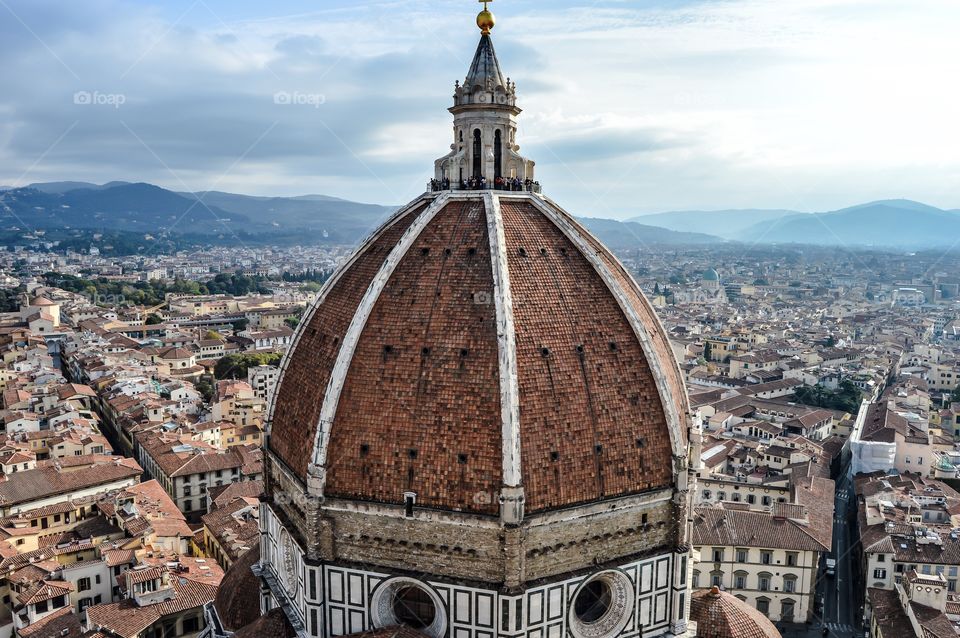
[269,192,687,515]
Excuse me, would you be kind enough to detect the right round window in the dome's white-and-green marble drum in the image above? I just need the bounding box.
[569,571,635,638]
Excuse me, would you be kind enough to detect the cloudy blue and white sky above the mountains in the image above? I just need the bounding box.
[0,0,960,218]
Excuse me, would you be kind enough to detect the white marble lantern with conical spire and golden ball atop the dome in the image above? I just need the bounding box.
[434,2,534,187]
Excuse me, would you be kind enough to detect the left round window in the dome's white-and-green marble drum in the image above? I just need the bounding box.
[370,577,447,638]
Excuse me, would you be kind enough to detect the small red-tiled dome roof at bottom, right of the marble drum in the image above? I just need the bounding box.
[690,587,781,638]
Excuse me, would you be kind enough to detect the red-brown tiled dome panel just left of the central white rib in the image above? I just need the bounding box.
[326,199,501,515]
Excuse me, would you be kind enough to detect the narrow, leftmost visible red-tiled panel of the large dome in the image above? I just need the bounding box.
[269,203,426,480]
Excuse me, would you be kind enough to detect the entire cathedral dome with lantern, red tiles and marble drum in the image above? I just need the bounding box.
[218,9,696,638]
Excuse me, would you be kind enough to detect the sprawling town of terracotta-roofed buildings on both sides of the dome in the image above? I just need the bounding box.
[0,243,960,638]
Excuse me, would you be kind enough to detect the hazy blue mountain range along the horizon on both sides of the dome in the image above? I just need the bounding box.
[0,181,960,249]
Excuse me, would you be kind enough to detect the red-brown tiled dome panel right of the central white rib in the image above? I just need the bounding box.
[500,196,673,512]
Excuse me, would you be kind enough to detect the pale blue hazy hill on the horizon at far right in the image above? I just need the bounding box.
[737,199,960,248]
